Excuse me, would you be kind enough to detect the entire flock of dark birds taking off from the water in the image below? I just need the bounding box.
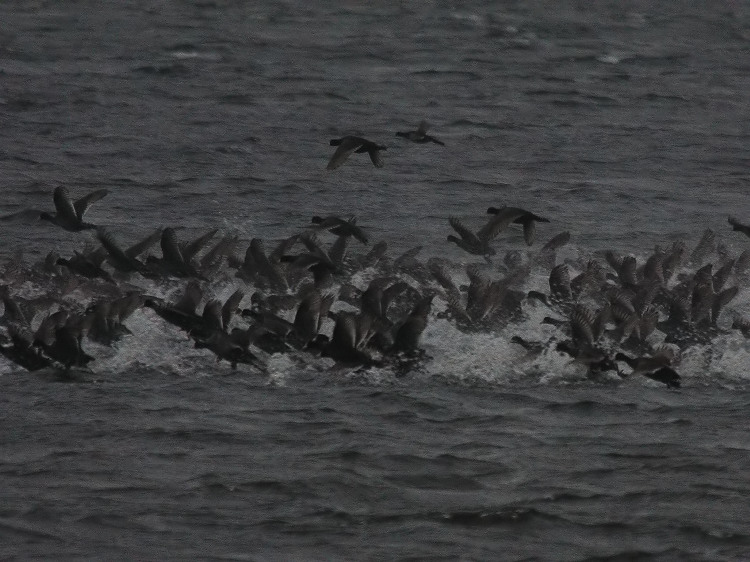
[0,123,750,387]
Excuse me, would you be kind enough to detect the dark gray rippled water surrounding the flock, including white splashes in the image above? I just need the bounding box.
[0,1,750,560]
